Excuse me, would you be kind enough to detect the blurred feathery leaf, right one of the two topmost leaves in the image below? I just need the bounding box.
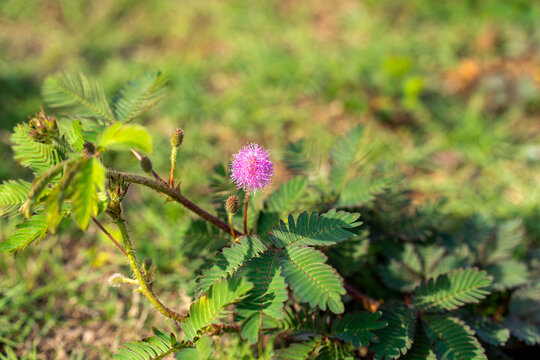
[113,72,168,122]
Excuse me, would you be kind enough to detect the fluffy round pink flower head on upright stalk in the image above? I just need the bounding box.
[231,144,274,192]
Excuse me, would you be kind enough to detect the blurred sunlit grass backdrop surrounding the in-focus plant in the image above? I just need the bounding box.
[0,0,540,359]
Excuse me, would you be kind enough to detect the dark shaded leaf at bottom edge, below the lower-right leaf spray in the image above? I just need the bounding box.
[371,303,416,360]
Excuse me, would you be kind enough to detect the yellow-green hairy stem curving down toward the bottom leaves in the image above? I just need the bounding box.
[115,217,186,322]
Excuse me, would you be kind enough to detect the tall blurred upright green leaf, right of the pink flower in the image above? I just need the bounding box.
[330,126,366,192]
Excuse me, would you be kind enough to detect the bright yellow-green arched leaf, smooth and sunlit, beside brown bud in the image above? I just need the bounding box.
[96,123,152,153]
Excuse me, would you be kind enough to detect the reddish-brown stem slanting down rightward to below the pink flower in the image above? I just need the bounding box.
[107,170,244,237]
